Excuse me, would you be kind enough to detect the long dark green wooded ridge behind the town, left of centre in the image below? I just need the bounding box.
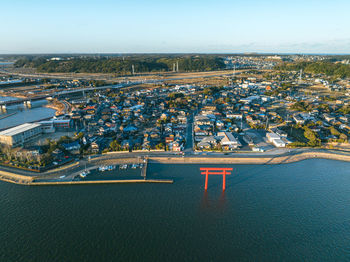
[15,56,225,75]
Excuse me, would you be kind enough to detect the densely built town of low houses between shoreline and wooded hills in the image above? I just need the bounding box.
[0,55,350,171]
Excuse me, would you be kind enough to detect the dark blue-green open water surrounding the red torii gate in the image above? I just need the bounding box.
[0,160,350,262]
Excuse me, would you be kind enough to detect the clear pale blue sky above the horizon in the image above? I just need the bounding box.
[0,0,350,53]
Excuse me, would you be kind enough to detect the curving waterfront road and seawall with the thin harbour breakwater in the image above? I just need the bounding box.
[0,149,350,185]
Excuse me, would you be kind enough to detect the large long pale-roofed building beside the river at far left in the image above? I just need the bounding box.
[0,123,42,147]
